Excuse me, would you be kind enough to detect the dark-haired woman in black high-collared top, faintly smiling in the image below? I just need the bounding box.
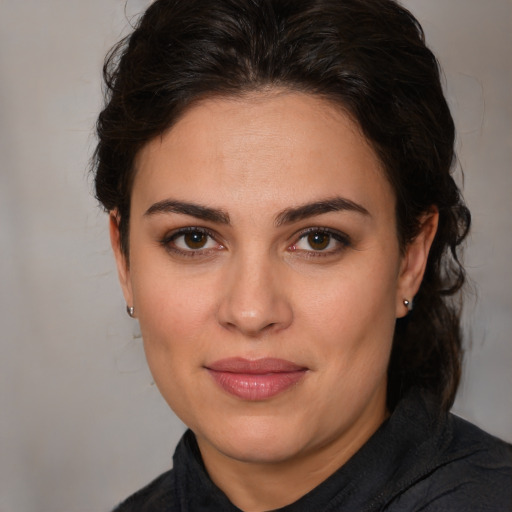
[96,0,512,511]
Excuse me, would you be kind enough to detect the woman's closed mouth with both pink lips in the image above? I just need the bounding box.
[206,357,308,401]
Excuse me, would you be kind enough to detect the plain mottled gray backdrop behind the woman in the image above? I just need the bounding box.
[0,0,512,512]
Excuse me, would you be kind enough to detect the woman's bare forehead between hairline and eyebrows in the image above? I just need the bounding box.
[133,92,394,217]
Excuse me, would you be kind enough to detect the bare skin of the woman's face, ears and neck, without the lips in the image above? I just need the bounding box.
[110,91,437,511]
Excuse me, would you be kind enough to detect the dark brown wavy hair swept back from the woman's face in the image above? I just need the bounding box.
[94,0,470,409]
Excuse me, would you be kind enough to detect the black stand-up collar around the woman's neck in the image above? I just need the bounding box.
[174,390,444,512]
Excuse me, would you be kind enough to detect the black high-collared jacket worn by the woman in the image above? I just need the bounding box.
[114,391,512,512]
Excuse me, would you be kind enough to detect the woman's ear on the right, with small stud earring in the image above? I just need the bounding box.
[396,207,439,318]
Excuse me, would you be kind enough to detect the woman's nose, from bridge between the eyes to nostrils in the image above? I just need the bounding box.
[217,250,293,338]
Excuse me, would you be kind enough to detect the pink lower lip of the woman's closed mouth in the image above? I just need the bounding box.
[209,370,306,401]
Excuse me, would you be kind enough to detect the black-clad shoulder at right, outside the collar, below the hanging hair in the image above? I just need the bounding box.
[387,414,512,512]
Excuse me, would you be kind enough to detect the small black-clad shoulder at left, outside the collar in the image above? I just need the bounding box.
[113,469,177,512]
